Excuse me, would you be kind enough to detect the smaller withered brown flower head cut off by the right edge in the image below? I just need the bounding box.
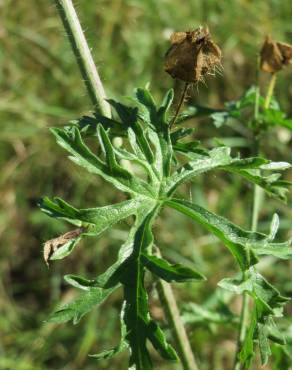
[260,36,292,73]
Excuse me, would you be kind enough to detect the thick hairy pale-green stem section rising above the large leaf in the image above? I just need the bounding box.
[55,0,111,117]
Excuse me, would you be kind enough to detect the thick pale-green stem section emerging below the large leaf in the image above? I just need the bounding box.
[156,248,198,370]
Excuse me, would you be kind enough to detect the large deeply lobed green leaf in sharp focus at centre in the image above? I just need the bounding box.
[40,89,291,370]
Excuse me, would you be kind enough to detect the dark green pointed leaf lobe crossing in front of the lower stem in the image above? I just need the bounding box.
[142,254,206,282]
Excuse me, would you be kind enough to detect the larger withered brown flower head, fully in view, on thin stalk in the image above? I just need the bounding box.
[164,27,221,83]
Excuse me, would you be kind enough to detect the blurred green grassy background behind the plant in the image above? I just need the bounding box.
[0,0,292,370]
